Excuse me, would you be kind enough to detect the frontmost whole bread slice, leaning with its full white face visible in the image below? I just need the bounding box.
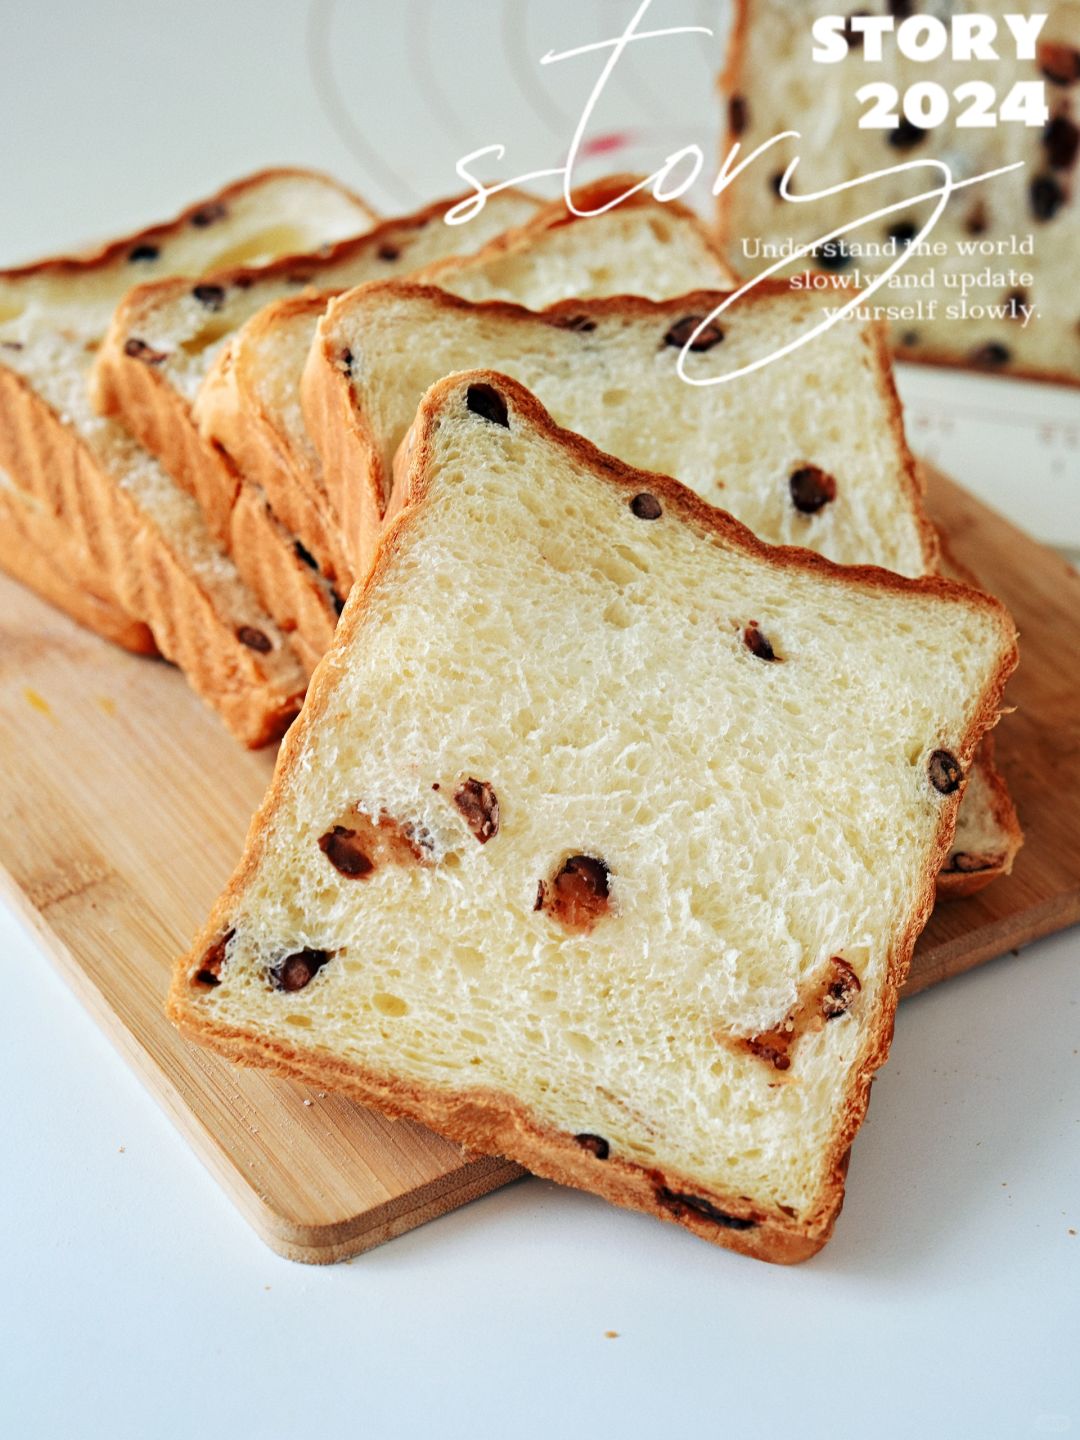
[170,370,1015,1261]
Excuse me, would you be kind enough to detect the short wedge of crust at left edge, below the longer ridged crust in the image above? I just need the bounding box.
[0,490,158,655]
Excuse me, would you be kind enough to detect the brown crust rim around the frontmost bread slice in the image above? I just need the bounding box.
[167,370,1017,1263]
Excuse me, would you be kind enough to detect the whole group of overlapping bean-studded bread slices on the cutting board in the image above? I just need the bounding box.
[0,171,1021,1260]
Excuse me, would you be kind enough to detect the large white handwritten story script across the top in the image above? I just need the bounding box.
[445,0,1024,386]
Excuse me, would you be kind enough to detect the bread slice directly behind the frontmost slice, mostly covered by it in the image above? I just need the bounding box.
[305,281,1022,897]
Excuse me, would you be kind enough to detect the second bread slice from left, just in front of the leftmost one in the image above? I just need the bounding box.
[92,190,539,665]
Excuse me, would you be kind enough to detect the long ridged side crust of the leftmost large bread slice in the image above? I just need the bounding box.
[0,369,304,749]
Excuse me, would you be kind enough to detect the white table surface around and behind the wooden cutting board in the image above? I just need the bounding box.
[0,0,1080,1440]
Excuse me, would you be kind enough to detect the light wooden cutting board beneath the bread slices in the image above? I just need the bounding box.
[0,475,1080,1261]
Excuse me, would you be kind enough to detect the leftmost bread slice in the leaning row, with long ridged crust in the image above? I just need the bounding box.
[0,170,369,744]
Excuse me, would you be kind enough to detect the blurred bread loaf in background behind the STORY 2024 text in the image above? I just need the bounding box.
[719,0,1080,384]
